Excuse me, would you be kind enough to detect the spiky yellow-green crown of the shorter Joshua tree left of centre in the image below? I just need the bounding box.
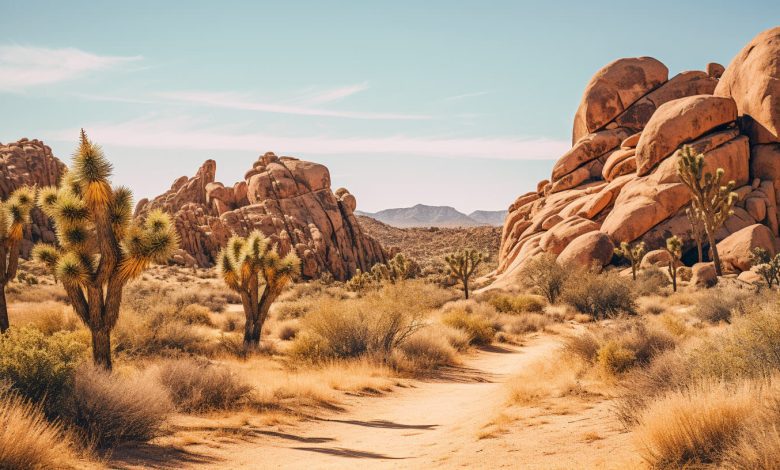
[217,230,301,292]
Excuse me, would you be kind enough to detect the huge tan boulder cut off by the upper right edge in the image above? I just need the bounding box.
[715,26,780,144]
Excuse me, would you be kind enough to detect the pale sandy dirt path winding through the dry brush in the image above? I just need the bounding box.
[160,335,640,469]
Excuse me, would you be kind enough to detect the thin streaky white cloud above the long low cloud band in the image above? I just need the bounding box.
[158,88,432,120]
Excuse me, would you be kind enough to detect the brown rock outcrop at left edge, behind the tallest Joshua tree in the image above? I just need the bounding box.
[0,138,66,257]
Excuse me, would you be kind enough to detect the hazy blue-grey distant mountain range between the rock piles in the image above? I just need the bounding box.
[355,204,506,228]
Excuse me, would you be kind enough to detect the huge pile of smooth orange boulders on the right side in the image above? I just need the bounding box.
[497,27,780,282]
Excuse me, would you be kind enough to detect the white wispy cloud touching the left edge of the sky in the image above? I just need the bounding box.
[0,45,141,92]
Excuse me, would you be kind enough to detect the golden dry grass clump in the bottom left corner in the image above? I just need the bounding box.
[0,389,76,470]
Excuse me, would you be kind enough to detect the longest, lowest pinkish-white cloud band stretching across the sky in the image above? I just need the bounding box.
[45,117,571,160]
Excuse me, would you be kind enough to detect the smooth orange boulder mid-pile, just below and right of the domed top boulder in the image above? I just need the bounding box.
[636,95,737,176]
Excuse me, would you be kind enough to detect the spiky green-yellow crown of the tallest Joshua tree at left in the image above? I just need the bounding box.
[33,131,179,287]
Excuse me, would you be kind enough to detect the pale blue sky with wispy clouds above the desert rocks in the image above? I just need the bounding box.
[0,0,780,212]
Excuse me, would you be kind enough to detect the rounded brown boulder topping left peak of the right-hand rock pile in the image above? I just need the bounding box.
[572,57,669,144]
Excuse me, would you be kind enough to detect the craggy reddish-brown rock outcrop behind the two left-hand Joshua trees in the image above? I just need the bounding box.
[136,152,386,280]
